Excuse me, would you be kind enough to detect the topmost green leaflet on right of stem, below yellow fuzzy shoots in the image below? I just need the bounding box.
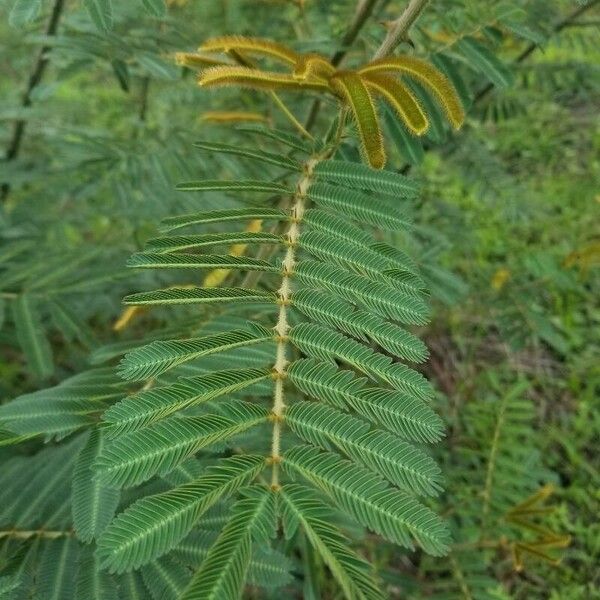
[314,160,419,198]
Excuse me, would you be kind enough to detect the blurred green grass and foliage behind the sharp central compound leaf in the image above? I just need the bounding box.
[0,0,600,600]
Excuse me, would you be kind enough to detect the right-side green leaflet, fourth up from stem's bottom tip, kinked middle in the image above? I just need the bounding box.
[288,359,444,443]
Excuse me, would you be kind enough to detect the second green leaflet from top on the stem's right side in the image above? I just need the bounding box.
[308,183,411,231]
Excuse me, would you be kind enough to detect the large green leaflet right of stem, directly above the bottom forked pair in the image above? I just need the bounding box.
[283,446,450,556]
